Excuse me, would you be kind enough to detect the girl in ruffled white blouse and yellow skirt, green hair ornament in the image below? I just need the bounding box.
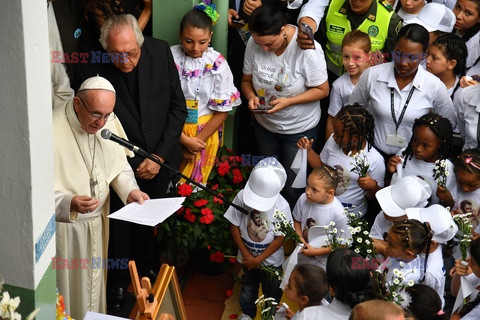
[171,0,241,184]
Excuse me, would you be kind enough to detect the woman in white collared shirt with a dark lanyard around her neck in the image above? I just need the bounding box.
[349,23,456,160]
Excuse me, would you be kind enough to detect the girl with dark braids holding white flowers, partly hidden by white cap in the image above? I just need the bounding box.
[387,113,456,207]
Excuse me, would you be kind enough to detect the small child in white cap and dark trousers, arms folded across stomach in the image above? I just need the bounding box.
[224,158,292,319]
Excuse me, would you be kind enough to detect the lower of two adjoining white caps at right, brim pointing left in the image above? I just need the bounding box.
[405,204,458,243]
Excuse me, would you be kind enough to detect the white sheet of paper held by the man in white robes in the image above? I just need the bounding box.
[108,197,185,227]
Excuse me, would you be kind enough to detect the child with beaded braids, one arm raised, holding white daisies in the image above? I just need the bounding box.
[297,103,385,215]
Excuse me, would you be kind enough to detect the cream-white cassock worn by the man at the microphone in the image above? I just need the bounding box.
[52,101,138,319]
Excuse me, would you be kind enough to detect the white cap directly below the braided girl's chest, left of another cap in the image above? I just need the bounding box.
[375,176,432,218]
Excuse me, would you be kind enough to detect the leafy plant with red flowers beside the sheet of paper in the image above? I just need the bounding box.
[157,147,251,265]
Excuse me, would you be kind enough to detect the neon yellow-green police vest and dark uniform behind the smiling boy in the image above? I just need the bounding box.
[320,0,403,76]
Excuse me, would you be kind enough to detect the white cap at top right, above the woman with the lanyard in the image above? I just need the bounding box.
[405,3,457,32]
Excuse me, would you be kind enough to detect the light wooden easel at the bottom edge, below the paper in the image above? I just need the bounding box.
[128,261,187,320]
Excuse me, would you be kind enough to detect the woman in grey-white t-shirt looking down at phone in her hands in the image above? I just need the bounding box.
[241,6,329,207]
